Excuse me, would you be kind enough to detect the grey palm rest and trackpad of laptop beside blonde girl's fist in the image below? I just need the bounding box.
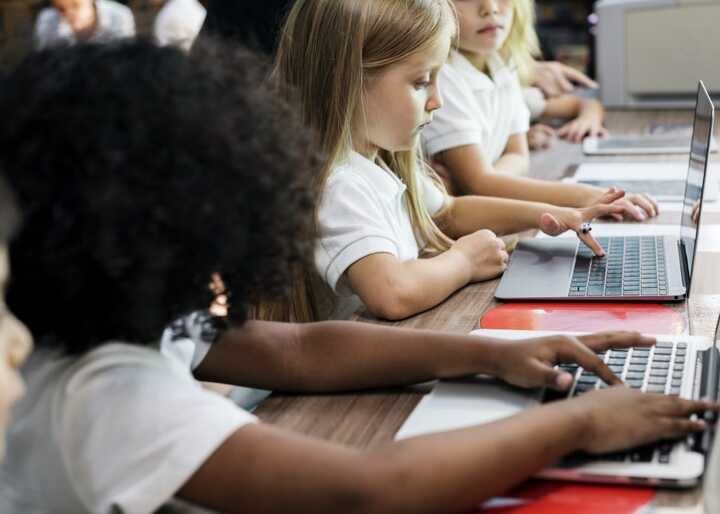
[495,237,578,299]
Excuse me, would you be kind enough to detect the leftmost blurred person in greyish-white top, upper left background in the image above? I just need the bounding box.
[35,0,135,48]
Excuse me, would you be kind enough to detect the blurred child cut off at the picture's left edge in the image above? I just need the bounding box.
[0,177,32,461]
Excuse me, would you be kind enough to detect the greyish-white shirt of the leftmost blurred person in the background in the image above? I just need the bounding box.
[35,0,135,49]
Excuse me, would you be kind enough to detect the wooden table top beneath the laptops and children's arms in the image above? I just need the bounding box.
[257,111,720,514]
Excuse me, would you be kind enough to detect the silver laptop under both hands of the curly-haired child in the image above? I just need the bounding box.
[396,320,720,488]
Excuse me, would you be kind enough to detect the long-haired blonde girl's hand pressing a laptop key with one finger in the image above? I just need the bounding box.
[539,195,625,257]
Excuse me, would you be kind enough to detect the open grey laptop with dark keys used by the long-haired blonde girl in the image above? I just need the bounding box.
[495,82,715,302]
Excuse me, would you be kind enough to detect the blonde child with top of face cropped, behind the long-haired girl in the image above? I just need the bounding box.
[423,0,658,221]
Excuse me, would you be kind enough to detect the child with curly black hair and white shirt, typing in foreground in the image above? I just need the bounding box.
[0,42,714,514]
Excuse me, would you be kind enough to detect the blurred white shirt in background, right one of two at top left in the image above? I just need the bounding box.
[153,0,207,51]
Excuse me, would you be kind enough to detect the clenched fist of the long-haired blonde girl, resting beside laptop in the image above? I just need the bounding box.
[449,230,509,282]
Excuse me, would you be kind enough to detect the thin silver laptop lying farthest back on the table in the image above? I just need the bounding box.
[583,134,718,155]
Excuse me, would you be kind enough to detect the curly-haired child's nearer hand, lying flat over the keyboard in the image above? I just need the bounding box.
[568,387,720,453]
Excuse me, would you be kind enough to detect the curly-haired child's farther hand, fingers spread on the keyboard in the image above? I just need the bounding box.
[495,332,655,391]
